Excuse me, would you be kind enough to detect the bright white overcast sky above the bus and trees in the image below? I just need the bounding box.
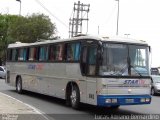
[0,0,160,67]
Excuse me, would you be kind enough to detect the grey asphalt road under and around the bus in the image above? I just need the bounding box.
[0,79,160,120]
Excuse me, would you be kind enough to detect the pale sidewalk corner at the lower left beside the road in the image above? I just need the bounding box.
[0,92,50,120]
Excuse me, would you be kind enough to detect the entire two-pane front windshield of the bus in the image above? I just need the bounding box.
[99,43,149,76]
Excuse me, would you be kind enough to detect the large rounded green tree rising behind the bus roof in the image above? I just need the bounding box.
[9,14,56,42]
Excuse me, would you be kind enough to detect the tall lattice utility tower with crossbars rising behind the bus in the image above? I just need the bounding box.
[69,1,90,37]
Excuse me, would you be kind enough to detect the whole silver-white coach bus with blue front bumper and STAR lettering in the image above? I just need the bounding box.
[6,36,151,108]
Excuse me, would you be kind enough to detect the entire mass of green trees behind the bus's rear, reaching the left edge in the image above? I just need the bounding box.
[0,14,56,63]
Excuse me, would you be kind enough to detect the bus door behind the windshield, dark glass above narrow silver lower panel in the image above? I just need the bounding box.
[81,44,98,104]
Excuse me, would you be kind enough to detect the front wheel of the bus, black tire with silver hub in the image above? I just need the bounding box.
[70,85,80,109]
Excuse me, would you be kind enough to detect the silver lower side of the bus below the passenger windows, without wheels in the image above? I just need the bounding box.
[7,62,90,103]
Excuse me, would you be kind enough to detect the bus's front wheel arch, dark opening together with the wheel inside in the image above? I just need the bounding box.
[65,81,80,109]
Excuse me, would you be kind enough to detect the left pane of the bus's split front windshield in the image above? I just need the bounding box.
[99,44,128,75]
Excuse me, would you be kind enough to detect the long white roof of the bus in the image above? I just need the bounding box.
[8,35,148,48]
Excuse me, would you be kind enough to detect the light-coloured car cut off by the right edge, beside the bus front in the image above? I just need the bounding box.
[151,75,160,95]
